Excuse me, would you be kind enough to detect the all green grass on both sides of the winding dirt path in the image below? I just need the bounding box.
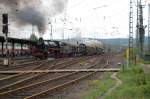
[81,62,150,99]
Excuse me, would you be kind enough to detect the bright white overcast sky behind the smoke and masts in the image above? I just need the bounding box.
[1,0,148,39]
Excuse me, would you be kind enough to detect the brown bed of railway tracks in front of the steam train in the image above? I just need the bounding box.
[0,54,123,99]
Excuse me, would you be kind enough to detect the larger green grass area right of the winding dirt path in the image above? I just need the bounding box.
[105,66,150,99]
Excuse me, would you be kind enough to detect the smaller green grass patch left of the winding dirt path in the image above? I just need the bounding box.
[82,73,115,99]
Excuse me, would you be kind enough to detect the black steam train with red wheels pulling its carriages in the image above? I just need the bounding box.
[31,38,104,59]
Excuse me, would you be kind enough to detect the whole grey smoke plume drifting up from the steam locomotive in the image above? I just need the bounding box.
[0,0,67,33]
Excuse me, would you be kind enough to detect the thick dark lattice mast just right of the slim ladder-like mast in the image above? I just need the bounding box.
[136,0,145,58]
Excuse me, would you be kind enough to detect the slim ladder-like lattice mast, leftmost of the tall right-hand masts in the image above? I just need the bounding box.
[128,0,134,65]
